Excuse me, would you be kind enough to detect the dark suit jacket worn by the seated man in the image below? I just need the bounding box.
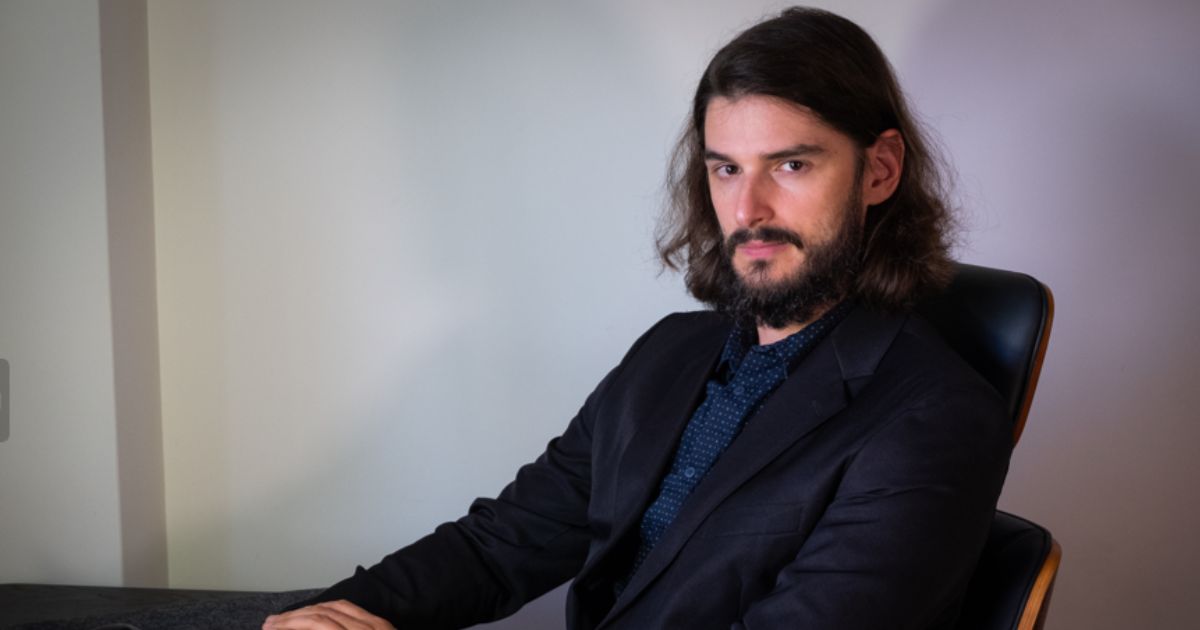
[302,303,1012,630]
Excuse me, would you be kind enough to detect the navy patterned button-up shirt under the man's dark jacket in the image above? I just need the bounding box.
[618,302,850,583]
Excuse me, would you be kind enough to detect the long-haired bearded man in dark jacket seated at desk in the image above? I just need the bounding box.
[264,8,1010,630]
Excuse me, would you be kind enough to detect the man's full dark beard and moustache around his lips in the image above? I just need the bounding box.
[722,194,863,329]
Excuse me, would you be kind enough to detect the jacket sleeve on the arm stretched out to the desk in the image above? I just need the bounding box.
[285,322,661,629]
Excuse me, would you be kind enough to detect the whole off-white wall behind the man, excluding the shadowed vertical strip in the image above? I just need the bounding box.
[0,0,1200,629]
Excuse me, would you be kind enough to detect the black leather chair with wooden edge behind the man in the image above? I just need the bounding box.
[918,264,1062,630]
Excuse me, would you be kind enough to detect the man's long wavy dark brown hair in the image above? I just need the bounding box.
[658,7,954,311]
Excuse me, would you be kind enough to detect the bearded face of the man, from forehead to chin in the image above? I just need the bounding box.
[704,95,866,328]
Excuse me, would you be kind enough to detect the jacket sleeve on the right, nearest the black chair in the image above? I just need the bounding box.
[733,389,1012,630]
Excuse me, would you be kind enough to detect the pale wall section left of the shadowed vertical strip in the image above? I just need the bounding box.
[0,1,122,584]
